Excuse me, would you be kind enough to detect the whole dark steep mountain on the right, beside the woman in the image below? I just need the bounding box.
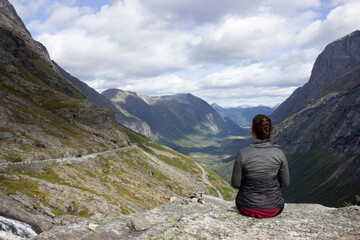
[271,31,360,206]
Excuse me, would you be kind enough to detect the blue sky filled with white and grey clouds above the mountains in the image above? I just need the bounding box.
[10,0,360,107]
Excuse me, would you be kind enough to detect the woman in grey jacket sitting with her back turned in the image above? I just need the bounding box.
[231,114,290,218]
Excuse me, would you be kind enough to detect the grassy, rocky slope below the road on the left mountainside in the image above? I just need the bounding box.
[0,129,235,217]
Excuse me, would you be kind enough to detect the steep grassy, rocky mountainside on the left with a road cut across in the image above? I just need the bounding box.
[0,0,235,233]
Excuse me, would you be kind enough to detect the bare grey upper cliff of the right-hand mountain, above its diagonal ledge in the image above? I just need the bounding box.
[272,31,360,123]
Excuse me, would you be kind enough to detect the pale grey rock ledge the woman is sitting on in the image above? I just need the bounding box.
[34,196,360,240]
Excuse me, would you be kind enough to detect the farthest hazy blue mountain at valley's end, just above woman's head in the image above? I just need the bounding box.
[211,103,274,127]
